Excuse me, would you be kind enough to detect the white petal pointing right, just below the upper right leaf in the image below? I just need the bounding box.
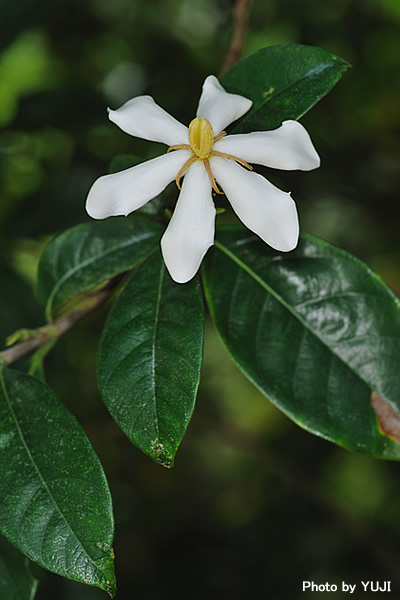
[214,121,320,171]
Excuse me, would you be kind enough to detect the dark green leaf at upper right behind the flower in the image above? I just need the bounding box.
[221,44,351,133]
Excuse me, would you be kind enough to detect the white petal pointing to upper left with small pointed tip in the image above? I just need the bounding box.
[108,96,189,146]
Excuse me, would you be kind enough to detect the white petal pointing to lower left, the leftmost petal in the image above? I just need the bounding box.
[86,150,191,219]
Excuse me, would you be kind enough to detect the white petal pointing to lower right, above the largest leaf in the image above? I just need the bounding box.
[210,156,299,252]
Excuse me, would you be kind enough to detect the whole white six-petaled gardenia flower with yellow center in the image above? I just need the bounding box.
[86,76,319,283]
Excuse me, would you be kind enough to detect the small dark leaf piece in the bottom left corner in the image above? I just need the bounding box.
[0,536,38,600]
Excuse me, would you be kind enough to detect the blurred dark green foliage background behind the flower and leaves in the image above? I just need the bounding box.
[0,0,400,600]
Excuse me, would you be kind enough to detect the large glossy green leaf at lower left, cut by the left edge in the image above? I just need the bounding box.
[0,368,115,596]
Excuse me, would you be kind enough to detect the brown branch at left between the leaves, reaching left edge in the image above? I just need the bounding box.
[0,281,115,364]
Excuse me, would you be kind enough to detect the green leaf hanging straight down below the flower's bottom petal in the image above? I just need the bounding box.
[98,251,204,467]
